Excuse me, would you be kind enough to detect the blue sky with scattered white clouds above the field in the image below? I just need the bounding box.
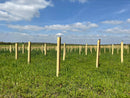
[0,0,130,44]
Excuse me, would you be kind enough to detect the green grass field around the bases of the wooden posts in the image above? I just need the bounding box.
[0,47,130,98]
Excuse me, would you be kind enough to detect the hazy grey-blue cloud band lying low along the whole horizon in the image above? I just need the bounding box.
[0,32,130,45]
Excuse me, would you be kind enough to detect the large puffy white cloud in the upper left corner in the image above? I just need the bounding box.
[0,0,52,21]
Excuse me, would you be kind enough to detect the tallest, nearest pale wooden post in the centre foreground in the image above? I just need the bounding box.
[56,37,61,77]
